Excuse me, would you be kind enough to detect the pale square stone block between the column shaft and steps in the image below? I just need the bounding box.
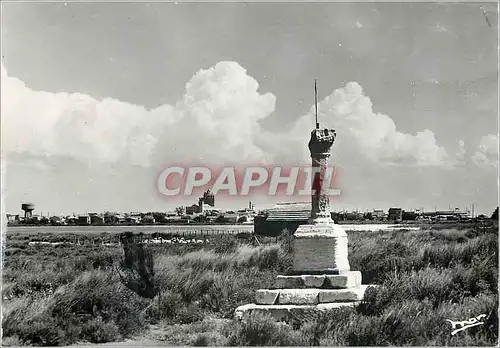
[292,221,350,274]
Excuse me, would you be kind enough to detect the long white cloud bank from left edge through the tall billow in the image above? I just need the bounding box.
[1,62,275,166]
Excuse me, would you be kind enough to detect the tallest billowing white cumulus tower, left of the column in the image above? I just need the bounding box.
[162,62,276,162]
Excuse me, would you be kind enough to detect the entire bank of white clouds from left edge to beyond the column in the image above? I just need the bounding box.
[1,62,448,171]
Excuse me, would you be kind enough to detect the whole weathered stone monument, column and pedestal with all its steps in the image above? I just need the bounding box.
[235,81,368,319]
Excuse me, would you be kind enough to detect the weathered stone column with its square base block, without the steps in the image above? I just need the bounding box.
[290,129,350,274]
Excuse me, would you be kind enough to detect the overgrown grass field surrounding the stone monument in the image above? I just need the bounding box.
[2,223,498,346]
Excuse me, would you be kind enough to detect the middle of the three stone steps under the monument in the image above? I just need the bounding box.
[255,285,369,305]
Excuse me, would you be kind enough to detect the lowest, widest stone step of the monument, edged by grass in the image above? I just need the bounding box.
[234,302,359,320]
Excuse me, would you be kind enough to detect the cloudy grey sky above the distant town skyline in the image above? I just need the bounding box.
[1,2,498,214]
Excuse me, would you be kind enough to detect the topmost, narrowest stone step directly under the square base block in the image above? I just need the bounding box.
[274,271,361,289]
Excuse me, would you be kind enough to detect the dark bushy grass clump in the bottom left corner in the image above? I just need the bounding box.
[3,271,145,345]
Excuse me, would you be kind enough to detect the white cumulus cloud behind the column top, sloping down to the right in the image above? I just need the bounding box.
[260,82,450,166]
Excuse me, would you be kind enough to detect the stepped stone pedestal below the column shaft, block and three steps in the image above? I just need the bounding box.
[235,219,368,320]
